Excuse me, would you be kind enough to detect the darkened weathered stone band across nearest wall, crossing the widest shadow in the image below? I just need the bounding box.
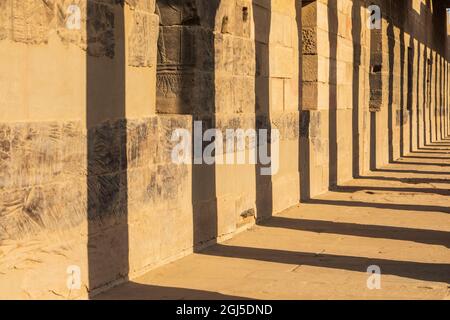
[0,117,185,239]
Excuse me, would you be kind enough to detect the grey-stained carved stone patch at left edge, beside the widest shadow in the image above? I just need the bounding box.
[0,122,86,241]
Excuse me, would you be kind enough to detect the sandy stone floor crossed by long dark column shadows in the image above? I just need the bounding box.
[97,141,450,299]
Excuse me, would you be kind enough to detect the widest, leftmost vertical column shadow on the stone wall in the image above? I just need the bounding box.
[86,1,129,296]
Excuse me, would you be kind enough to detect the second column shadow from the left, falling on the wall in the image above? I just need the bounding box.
[191,0,220,252]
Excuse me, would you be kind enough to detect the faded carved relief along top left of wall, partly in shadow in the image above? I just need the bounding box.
[0,0,120,58]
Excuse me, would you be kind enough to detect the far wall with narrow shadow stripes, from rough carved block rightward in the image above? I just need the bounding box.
[301,0,449,198]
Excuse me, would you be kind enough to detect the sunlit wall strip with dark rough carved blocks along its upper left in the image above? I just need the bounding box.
[301,1,335,196]
